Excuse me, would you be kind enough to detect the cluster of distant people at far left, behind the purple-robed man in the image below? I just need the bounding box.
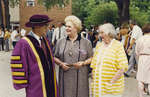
[0,26,26,52]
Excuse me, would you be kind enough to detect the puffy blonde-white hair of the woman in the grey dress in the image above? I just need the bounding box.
[65,15,82,31]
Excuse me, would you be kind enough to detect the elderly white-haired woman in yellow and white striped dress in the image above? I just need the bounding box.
[87,23,128,97]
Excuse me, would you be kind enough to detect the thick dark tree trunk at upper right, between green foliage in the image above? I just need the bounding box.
[115,0,130,25]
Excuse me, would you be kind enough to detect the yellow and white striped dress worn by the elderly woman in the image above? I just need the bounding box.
[91,39,128,97]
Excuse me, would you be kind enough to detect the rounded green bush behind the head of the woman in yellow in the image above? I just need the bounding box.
[85,2,118,26]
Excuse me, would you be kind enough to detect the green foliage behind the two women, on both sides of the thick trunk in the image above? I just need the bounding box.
[73,0,150,25]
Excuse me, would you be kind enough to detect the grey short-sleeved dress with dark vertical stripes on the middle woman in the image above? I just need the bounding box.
[55,35,93,97]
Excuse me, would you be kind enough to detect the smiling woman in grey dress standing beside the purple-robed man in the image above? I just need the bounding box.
[54,16,93,97]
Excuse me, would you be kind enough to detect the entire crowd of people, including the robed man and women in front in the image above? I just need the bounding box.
[7,15,150,97]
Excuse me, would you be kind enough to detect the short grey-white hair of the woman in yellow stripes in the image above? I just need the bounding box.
[99,23,116,38]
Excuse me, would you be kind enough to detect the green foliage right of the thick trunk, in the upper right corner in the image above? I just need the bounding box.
[130,0,150,26]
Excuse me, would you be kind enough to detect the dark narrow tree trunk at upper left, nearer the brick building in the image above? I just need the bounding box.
[3,0,10,29]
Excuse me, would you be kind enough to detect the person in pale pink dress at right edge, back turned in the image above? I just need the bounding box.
[135,24,150,97]
